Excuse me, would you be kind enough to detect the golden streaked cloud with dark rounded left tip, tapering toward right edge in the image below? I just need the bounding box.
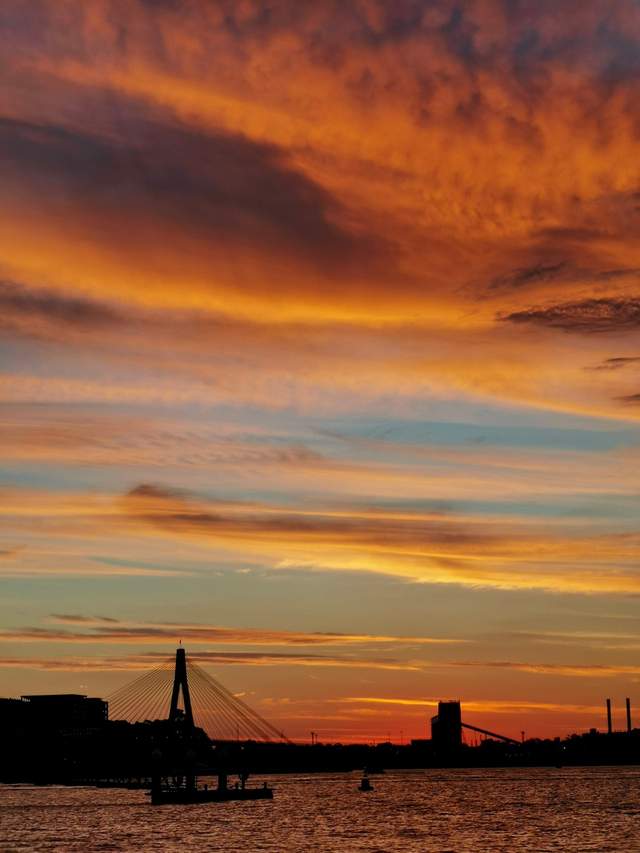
[117,485,639,592]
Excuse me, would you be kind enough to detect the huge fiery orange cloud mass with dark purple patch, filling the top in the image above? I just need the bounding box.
[0,0,640,396]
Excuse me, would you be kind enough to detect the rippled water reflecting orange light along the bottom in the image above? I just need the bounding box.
[0,767,640,853]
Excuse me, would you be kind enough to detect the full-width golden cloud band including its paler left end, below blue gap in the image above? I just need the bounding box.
[0,483,640,593]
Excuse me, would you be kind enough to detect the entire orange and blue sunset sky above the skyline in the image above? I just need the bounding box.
[0,0,640,741]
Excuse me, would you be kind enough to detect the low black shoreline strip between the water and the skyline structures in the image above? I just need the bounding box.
[0,723,640,788]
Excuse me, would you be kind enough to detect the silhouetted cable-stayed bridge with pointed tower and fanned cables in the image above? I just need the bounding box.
[107,647,290,743]
